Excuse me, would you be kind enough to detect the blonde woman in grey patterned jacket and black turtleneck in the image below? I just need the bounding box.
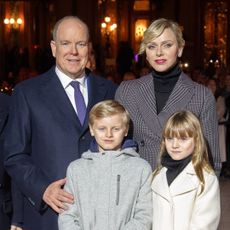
[115,18,221,174]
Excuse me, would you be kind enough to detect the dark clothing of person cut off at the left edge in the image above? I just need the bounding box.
[0,93,12,230]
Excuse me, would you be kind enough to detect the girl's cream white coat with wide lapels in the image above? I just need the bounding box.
[152,163,220,230]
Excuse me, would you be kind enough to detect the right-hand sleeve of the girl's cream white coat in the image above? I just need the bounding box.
[189,174,220,230]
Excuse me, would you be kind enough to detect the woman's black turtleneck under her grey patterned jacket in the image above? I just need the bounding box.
[152,64,181,114]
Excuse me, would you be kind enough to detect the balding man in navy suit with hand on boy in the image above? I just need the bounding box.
[4,16,116,230]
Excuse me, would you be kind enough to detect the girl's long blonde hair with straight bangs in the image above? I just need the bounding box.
[153,111,213,193]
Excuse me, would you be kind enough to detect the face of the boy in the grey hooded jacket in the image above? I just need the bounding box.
[90,114,128,152]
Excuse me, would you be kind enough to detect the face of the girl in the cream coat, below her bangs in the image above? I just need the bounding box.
[165,137,195,160]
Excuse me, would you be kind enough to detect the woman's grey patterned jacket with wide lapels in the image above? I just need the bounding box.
[115,73,221,171]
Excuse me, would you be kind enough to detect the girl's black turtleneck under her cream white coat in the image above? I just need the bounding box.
[161,153,192,186]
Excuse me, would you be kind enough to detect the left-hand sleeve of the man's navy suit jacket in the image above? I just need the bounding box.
[4,88,51,211]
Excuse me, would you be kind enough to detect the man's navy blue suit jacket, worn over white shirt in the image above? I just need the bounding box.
[5,67,116,230]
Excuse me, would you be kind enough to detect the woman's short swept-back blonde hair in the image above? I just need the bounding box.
[139,18,185,54]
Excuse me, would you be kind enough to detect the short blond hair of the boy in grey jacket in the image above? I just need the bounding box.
[89,100,130,127]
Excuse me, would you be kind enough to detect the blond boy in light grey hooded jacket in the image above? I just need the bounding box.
[58,100,152,230]
